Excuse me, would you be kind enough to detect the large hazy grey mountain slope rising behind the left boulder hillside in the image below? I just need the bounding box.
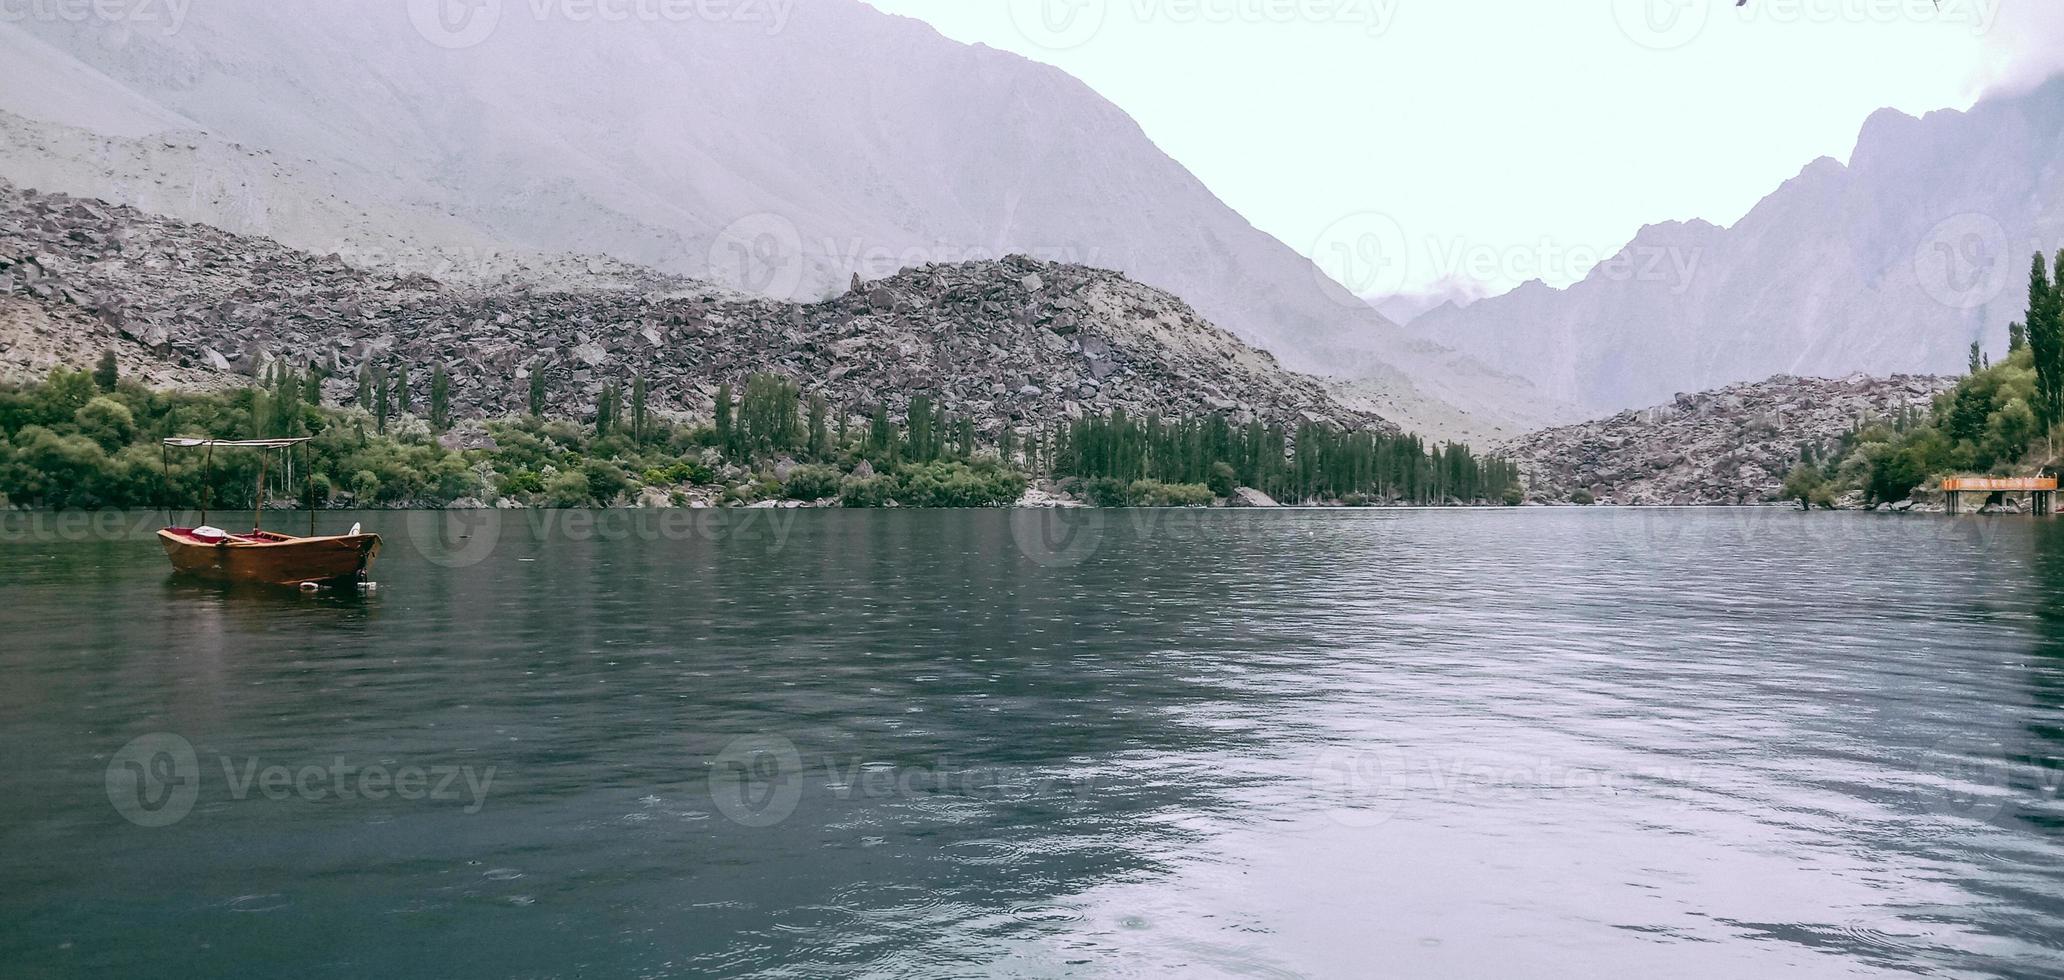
[0,0,1556,437]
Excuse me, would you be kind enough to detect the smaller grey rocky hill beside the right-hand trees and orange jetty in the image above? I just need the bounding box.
[1501,375,1955,503]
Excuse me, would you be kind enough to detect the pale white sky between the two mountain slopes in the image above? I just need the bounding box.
[869,0,2064,301]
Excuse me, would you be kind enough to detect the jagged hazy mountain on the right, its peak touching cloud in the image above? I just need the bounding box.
[1410,76,2064,413]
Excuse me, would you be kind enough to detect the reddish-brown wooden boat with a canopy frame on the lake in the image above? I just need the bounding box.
[157,439,380,586]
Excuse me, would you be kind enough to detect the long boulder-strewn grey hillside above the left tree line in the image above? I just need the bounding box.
[0,184,1389,431]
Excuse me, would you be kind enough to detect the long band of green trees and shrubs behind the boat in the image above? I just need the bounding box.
[0,353,1519,505]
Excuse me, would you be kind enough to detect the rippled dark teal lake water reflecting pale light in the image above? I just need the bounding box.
[0,510,2064,978]
